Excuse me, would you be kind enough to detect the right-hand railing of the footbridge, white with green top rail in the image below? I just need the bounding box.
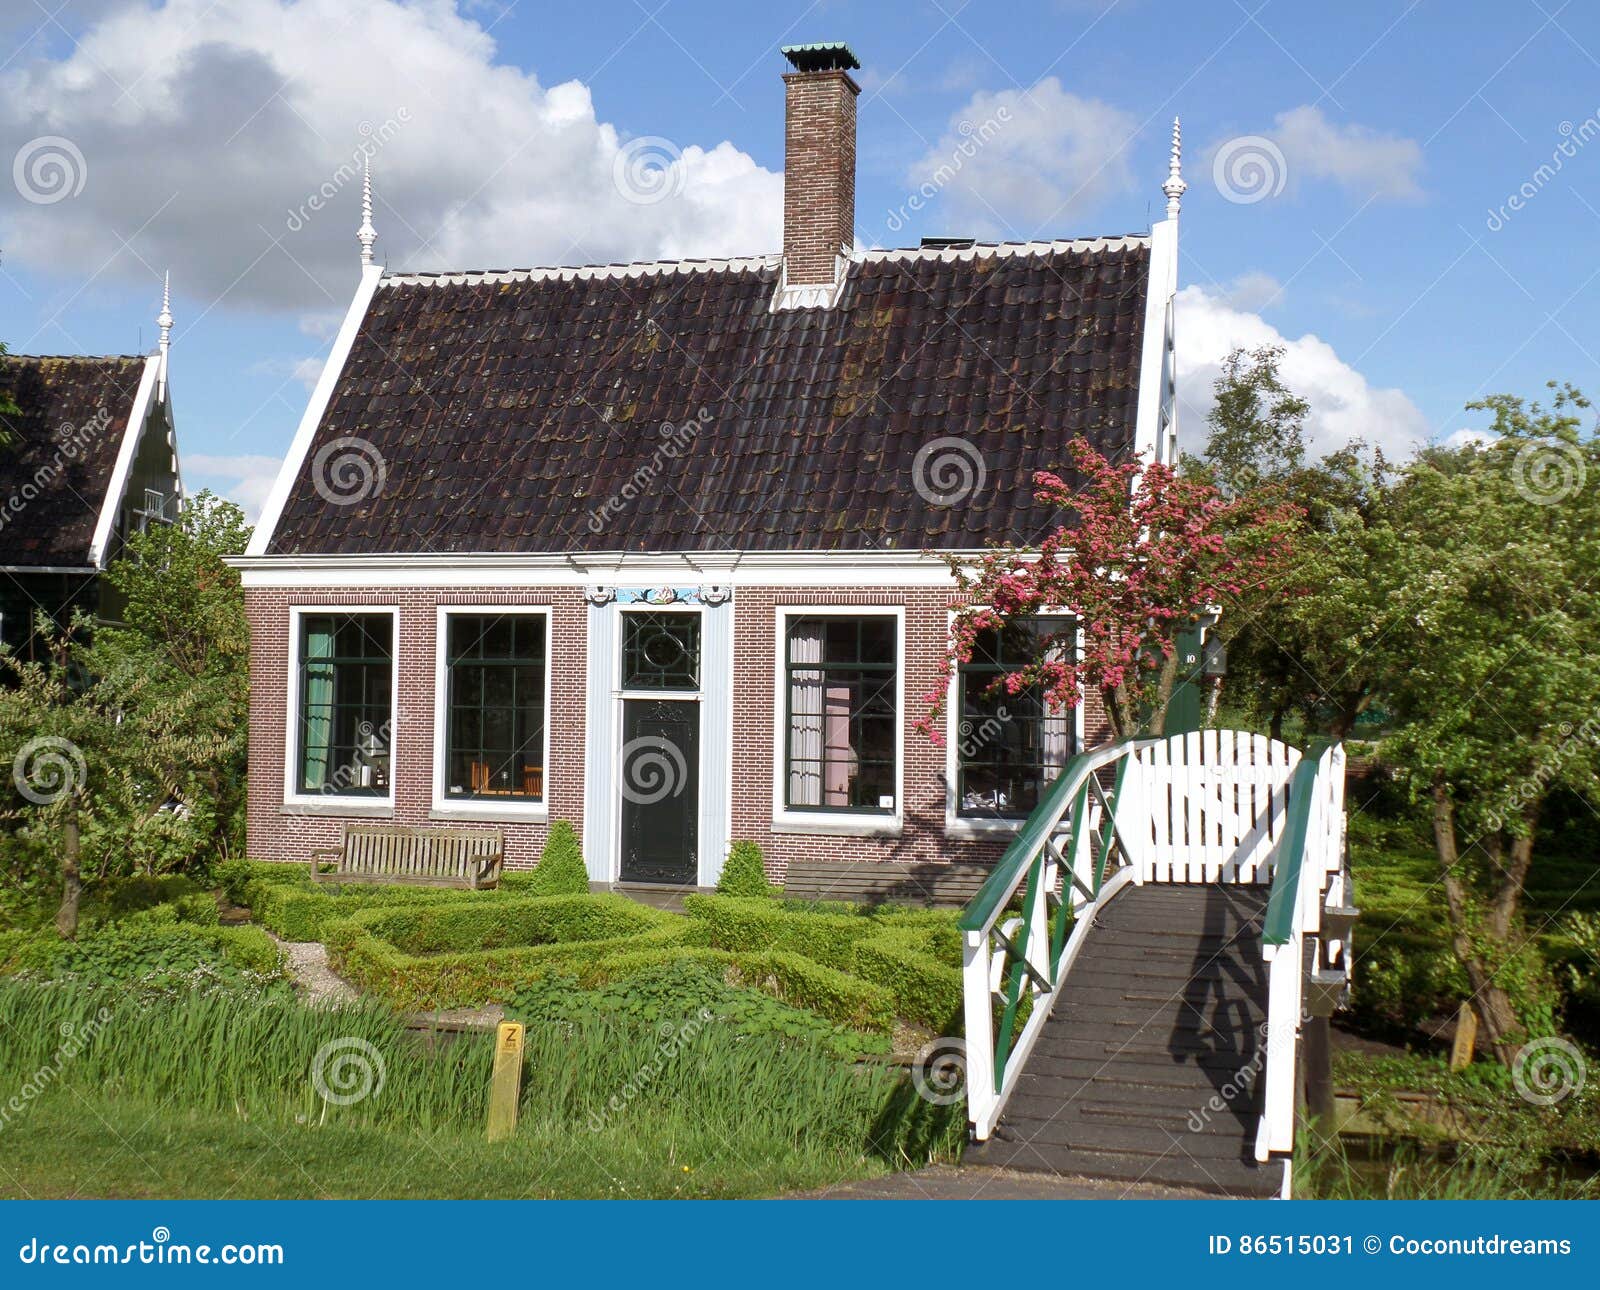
[1256,744,1349,1160]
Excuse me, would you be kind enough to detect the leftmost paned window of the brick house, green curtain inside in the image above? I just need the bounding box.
[296,613,394,797]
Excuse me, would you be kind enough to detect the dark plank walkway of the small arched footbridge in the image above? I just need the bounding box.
[968,885,1282,1196]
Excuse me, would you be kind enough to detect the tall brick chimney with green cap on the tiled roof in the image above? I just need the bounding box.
[782,43,861,288]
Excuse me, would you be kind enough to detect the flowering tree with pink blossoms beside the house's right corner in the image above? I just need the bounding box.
[918,439,1299,739]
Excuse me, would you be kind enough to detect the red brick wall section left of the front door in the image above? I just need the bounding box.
[245,587,587,867]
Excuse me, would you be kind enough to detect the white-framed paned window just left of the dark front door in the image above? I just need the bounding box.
[445,613,549,802]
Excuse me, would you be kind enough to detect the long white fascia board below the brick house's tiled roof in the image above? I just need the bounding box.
[227,551,981,591]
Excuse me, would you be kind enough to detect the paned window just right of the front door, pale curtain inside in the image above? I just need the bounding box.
[784,615,899,815]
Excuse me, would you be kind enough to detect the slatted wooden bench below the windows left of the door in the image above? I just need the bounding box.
[310,824,506,891]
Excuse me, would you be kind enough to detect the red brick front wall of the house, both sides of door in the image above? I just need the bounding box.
[245,587,1109,880]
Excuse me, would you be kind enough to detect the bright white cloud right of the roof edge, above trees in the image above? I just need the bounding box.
[1176,286,1432,456]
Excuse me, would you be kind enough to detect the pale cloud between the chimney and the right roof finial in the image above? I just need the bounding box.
[908,77,1138,237]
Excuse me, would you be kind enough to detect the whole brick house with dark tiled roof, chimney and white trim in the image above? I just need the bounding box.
[238,45,1182,885]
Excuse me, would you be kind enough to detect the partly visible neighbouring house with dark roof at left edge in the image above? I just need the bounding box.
[0,281,184,656]
